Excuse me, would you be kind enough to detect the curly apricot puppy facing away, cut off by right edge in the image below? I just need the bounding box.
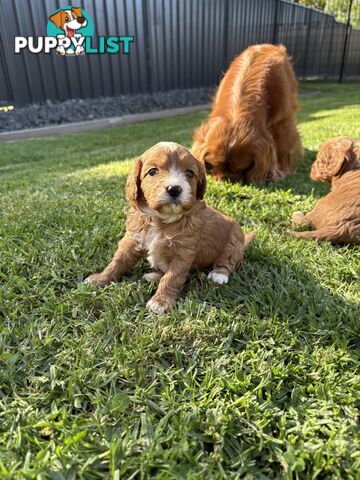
[289,137,360,244]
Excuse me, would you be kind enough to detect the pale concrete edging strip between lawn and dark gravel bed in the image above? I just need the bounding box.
[0,104,210,143]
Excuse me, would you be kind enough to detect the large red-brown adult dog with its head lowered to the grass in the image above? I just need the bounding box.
[191,44,303,182]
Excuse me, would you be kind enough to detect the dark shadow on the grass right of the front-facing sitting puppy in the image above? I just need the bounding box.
[182,244,360,345]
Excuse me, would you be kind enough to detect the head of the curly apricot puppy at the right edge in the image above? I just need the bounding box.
[310,137,354,182]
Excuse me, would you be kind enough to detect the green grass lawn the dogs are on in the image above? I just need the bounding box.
[0,84,360,480]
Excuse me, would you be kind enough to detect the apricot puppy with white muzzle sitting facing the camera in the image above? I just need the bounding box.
[86,142,255,312]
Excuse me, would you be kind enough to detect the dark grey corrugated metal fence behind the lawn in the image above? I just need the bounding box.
[0,0,360,104]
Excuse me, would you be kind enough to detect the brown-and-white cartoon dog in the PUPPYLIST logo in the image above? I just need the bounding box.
[49,7,87,55]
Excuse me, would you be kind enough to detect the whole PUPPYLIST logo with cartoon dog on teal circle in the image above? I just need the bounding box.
[15,6,134,56]
